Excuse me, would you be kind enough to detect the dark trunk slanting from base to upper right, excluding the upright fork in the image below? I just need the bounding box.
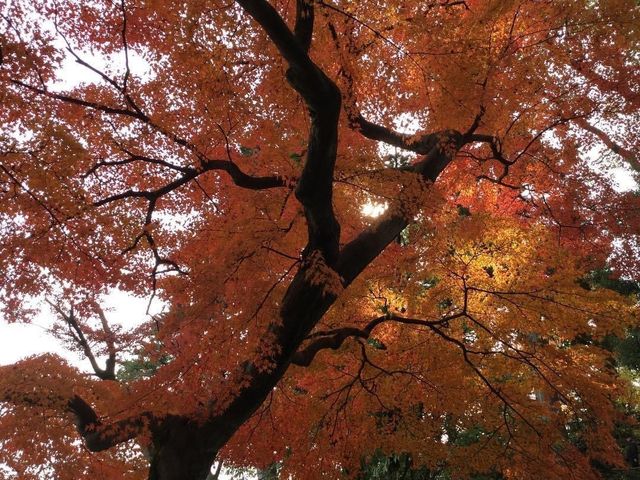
[144,132,463,480]
